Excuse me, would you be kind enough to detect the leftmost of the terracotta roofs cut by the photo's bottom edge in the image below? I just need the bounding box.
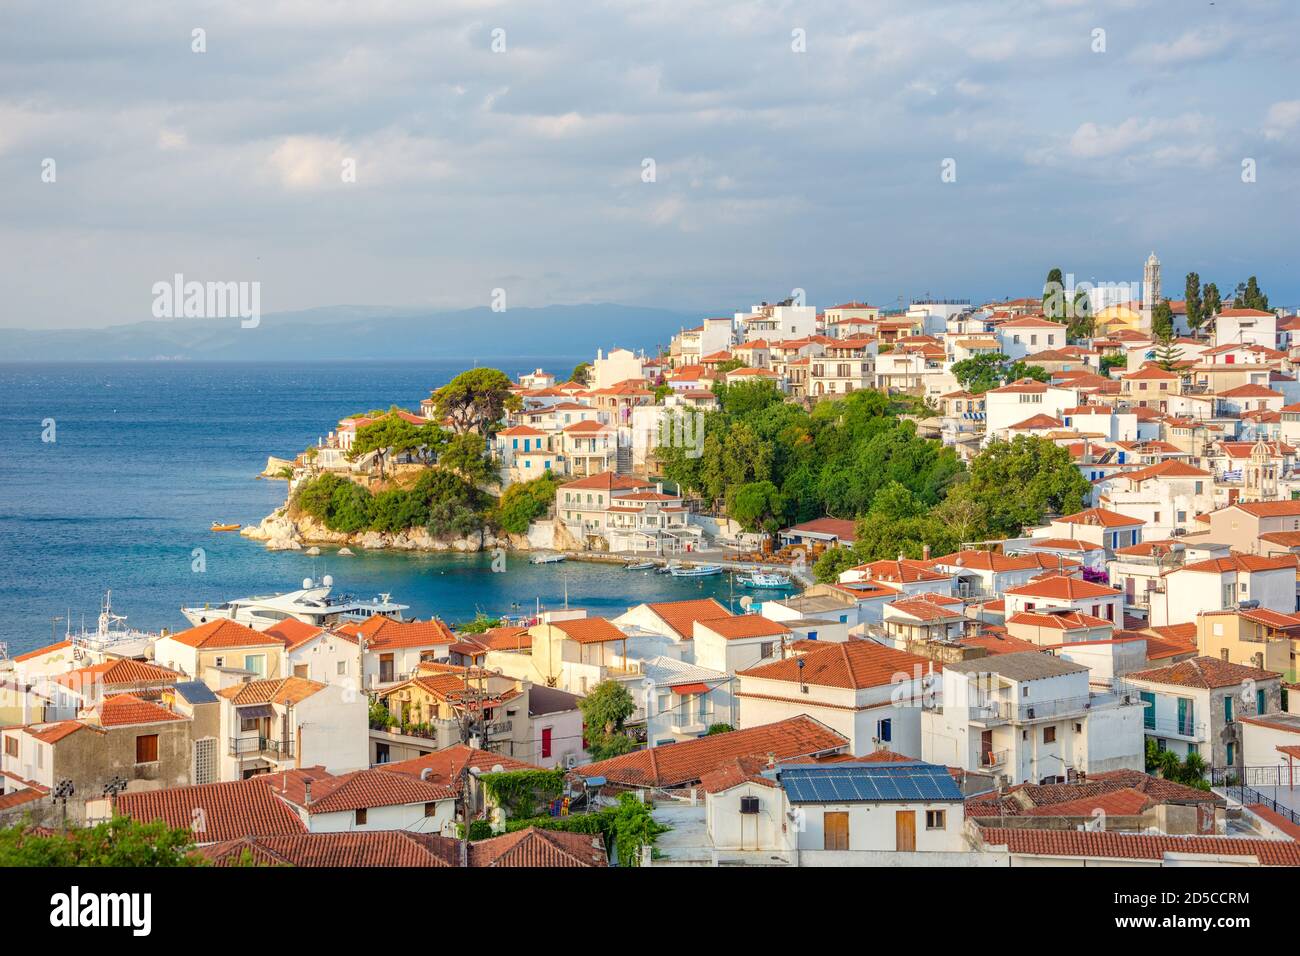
[199,830,460,868]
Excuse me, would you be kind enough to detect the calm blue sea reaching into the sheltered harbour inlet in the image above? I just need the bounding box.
[0,359,729,654]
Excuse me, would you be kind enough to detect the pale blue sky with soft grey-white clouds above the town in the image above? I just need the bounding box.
[0,0,1300,329]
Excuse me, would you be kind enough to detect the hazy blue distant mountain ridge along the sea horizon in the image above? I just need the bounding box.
[0,303,696,362]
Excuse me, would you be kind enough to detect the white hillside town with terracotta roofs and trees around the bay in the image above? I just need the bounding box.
[0,254,1300,868]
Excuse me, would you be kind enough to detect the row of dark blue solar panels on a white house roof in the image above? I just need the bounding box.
[781,763,962,804]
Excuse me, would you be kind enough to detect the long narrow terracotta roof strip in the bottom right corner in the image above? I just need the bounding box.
[980,829,1300,866]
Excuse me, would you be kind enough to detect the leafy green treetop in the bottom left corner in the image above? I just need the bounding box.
[0,817,207,868]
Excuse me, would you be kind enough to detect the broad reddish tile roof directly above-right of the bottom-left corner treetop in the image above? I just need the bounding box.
[117,779,306,843]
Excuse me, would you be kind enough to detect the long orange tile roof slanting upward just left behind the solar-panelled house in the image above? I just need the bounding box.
[575,714,849,787]
